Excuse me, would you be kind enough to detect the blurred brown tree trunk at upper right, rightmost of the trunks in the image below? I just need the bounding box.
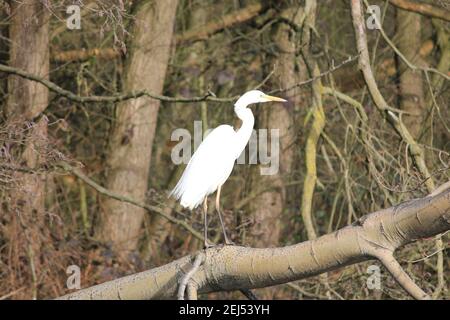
[397,10,425,139]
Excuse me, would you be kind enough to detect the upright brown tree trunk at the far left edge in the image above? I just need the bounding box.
[5,0,50,298]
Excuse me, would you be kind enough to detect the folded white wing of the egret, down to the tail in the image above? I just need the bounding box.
[171,125,236,208]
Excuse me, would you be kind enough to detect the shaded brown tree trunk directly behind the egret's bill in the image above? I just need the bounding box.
[251,6,305,247]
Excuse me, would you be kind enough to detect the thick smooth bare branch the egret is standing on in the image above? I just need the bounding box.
[60,182,450,299]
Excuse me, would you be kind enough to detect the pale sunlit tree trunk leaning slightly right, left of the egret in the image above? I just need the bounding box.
[99,0,178,251]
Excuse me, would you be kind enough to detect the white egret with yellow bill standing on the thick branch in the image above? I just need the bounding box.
[170,90,286,248]
